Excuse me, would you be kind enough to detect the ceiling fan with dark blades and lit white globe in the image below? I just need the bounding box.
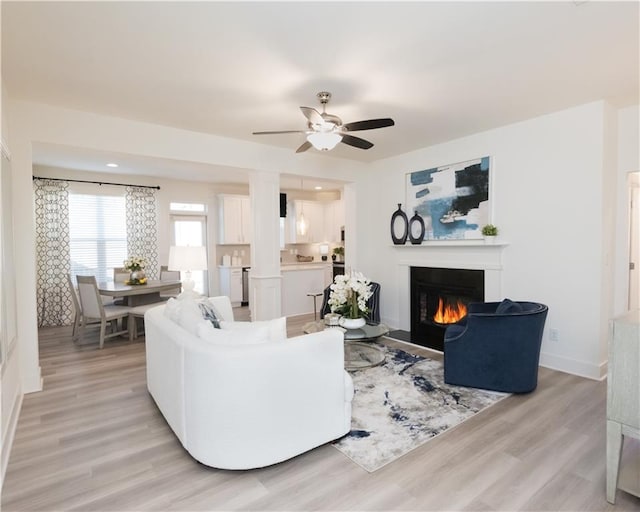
[253,91,395,153]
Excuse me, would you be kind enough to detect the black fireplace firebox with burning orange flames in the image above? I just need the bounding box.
[411,267,484,351]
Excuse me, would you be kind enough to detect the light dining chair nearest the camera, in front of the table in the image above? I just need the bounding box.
[76,276,131,348]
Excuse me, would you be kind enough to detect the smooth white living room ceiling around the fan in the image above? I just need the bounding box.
[2,1,640,182]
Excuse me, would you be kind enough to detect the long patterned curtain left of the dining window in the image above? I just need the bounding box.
[33,180,74,327]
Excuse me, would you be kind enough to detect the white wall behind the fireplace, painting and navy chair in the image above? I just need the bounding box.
[357,102,611,378]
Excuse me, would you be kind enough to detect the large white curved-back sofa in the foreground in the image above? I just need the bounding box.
[144,298,353,469]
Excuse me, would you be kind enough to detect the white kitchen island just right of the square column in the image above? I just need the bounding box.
[280,261,333,316]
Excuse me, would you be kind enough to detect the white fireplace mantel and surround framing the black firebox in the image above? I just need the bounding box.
[393,240,509,330]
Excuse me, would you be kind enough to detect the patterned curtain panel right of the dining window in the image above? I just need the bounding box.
[125,187,158,279]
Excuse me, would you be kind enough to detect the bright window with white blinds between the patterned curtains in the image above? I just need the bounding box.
[69,192,127,282]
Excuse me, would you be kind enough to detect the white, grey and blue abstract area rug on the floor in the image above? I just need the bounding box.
[333,345,509,472]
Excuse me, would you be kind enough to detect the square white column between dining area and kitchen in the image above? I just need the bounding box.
[249,171,282,320]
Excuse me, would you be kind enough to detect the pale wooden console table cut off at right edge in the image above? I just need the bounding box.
[607,310,640,503]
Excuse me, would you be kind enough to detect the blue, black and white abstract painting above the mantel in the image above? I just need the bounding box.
[406,156,491,241]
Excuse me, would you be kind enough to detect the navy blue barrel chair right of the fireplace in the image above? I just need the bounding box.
[444,299,549,393]
